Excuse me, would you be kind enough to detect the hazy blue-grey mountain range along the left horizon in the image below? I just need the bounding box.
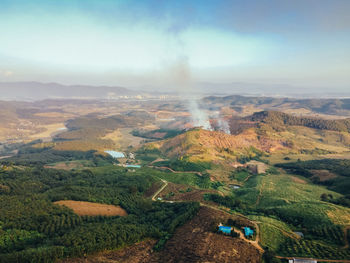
[0,82,146,100]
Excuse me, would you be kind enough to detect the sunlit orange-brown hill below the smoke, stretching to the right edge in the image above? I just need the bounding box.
[146,111,350,162]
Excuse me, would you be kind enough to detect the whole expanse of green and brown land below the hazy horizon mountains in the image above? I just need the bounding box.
[0,96,350,262]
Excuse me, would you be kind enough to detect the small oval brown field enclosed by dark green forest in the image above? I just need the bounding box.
[54,200,128,216]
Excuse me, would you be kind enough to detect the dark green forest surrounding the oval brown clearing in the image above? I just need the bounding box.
[0,165,199,263]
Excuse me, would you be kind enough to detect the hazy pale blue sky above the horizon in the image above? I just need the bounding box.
[0,0,350,90]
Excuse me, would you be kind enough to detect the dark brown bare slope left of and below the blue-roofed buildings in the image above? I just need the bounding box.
[150,207,260,263]
